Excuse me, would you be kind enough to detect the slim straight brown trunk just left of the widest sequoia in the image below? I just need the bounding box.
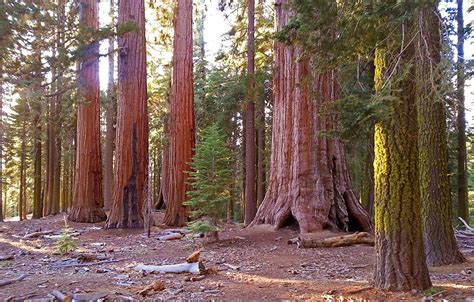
[244,0,257,225]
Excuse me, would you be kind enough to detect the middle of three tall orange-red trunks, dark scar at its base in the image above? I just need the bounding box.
[105,0,148,229]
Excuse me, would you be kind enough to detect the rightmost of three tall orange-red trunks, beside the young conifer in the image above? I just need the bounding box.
[163,0,196,226]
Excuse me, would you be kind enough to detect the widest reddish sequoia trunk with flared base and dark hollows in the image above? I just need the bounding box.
[252,0,371,232]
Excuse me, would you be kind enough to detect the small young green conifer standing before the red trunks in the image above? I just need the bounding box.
[185,125,233,240]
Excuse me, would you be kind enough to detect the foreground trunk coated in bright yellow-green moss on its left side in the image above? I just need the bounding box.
[374,46,431,291]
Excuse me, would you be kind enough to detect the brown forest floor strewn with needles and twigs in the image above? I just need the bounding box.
[0,215,474,301]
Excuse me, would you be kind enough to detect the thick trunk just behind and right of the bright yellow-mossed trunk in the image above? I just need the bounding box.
[416,4,465,266]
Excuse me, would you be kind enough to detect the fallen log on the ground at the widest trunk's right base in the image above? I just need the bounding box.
[298,232,374,248]
